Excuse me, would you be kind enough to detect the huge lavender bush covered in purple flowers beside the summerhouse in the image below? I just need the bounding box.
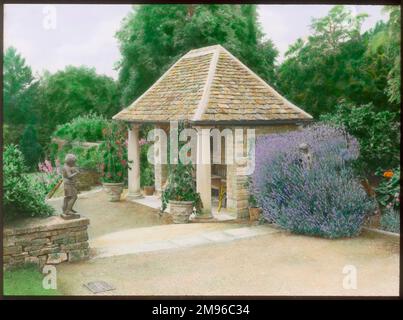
[251,125,374,238]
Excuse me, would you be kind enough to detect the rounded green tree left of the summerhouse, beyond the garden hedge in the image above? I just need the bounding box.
[36,66,120,144]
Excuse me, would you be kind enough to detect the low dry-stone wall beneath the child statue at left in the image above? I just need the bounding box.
[3,216,90,269]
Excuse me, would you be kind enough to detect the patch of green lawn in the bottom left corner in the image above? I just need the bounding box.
[3,266,61,296]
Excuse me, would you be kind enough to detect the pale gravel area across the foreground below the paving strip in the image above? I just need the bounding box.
[57,228,399,296]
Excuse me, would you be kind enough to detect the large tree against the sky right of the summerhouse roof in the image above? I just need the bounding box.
[278,6,399,117]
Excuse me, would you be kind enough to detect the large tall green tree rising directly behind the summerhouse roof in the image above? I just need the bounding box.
[116,5,277,106]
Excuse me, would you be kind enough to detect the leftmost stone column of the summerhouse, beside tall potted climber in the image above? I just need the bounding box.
[127,124,143,200]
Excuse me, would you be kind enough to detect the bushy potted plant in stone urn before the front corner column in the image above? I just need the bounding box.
[162,163,201,223]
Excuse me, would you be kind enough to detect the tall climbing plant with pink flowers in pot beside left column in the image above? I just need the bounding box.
[100,122,129,202]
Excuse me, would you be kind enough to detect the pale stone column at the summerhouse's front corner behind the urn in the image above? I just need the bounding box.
[195,127,213,218]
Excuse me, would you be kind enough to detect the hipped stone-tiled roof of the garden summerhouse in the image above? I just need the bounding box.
[114,45,312,123]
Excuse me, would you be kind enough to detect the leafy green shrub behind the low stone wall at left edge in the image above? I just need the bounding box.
[3,145,54,219]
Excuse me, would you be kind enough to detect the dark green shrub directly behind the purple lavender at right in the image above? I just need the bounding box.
[320,103,400,172]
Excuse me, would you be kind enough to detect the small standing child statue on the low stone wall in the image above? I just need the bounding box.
[61,154,80,219]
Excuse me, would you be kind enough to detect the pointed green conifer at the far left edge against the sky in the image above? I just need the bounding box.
[3,47,37,125]
